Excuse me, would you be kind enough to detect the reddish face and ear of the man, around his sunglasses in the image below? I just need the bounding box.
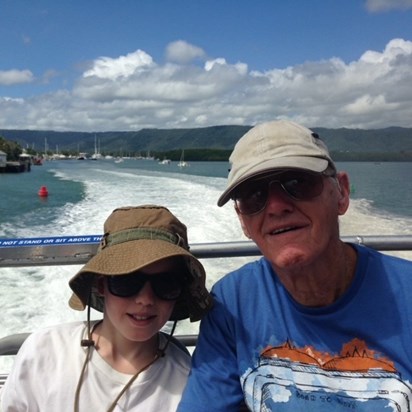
[235,172,349,271]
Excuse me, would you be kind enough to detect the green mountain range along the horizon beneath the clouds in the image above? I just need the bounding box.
[0,126,412,161]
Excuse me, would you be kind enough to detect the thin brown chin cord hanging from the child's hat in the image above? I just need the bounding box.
[74,296,177,412]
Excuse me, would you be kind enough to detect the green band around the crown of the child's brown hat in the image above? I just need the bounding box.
[100,228,185,249]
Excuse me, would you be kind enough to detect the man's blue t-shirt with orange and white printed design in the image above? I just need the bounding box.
[178,245,412,412]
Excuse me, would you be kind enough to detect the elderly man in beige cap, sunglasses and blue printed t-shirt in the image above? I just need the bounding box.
[178,120,412,412]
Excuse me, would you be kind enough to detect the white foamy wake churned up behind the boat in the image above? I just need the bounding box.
[0,163,412,371]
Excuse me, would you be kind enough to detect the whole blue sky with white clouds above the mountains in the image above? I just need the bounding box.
[0,0,412,132]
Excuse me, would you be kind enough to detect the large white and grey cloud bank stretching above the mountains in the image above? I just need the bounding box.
[0,39,412,131]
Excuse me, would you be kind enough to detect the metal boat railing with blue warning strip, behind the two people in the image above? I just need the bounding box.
[0,235,412,356]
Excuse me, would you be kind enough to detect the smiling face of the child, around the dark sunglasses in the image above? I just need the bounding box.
[104,259,177,342]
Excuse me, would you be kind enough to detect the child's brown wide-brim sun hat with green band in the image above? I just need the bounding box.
[69,205,212,321]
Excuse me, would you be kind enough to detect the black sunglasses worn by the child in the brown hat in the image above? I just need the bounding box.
[107,272,184,300]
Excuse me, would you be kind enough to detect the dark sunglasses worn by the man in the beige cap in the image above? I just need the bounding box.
[233,170,329,215]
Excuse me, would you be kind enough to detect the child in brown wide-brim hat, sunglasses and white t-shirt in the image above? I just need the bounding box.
[1,205,212,412]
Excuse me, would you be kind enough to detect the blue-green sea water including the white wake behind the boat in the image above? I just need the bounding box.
[0,159,412,371]
